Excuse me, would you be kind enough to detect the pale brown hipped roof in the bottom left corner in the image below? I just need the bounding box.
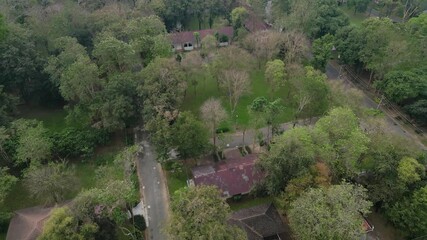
[6,207,53,240]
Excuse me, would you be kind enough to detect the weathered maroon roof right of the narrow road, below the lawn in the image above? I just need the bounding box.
[192,149,262,197]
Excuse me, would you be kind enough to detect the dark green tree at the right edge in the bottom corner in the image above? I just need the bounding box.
[387,186,427,238]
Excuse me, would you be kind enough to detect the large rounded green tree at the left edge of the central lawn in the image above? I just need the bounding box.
[138,58,187,118]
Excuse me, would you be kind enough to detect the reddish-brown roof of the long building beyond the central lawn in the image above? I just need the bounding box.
[170,27,234,45]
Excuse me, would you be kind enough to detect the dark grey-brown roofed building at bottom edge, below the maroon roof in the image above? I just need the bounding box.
[229,204,292,240]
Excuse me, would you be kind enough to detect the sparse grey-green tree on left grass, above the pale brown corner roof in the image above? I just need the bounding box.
[24,162,77,203]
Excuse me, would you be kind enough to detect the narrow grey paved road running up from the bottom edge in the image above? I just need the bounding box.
[137,134,169,240]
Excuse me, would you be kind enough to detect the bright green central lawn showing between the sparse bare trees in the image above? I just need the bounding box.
[183,69,294,126]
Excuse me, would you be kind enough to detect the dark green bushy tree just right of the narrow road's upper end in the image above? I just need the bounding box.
[172,112,209,159]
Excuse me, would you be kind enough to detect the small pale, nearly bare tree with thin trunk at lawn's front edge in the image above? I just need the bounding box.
[200,98,227,151]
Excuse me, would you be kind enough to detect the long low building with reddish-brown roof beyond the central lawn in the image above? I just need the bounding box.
[169,27,234,51]
